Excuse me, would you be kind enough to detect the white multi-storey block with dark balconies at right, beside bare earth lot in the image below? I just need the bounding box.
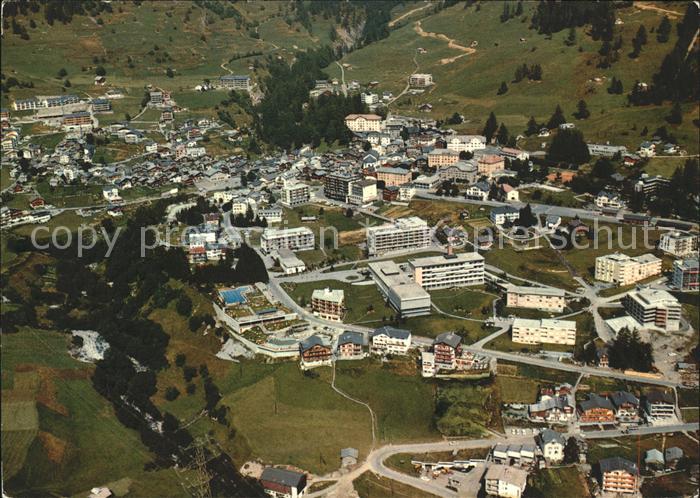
[622,288,681,331]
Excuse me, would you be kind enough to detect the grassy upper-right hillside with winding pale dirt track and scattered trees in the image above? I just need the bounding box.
[327,2,698,153]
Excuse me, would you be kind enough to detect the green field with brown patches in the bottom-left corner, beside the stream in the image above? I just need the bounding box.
[2,328,190,496]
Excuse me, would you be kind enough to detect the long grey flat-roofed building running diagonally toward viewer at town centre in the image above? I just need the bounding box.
[368,261,430,317]
